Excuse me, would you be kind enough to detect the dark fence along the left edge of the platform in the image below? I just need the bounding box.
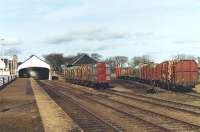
[0,76,16,90]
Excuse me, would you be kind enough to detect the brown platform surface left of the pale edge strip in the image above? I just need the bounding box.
[0,79,44,132]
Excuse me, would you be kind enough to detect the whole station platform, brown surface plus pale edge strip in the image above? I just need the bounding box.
[0,78,82,132]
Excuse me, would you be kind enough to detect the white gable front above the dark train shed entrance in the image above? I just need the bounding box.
[17,55,51,71]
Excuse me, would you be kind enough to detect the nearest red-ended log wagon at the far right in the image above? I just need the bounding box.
[161,60,198,90]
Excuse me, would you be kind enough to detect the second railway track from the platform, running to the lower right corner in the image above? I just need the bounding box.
[39,82,200,131]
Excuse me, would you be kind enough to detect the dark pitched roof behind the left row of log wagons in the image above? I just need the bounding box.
[66,54,97,66]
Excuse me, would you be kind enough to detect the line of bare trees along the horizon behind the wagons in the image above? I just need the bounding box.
[44,53,200,71]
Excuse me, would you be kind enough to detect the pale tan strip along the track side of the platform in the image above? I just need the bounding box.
[31,79,83,132]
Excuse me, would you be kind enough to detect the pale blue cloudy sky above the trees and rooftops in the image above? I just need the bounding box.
[0,0,200,62]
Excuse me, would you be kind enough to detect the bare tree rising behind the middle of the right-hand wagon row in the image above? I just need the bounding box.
[130,55,154,67]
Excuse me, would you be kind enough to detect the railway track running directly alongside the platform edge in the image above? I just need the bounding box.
[36,82,122,132]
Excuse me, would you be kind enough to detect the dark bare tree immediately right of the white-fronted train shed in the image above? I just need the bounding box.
[44,53,65,71]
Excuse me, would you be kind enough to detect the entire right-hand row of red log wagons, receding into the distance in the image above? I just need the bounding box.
[116,60,198,91]
